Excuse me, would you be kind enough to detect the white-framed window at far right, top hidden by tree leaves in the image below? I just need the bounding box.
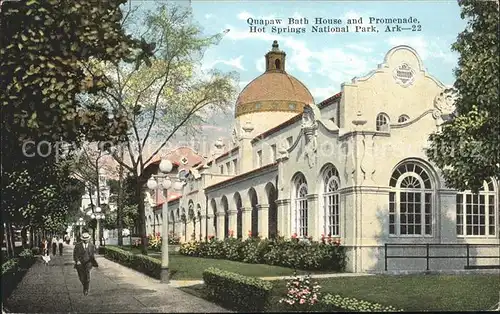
[457,179,498,236]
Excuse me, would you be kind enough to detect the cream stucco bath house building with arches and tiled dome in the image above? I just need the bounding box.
[148,41,500,272]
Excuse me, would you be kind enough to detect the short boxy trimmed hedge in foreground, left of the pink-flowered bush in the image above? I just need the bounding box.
[203,267,273,312]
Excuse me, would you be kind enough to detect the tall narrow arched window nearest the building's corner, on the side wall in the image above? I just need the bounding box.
[323,165,340,236]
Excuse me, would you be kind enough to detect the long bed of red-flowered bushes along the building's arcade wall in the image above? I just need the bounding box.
[179,237,346,271]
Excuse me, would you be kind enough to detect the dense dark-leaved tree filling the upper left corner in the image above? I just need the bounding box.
[0,0,150,251]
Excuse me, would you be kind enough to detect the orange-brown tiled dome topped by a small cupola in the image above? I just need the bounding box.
[235,40,314,117]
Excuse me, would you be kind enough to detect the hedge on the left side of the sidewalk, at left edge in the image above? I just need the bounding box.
[2,249,36,300]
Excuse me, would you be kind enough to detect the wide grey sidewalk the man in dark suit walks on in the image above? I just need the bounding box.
[3,246,228,313]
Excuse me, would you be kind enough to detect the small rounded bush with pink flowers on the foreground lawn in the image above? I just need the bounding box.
[279,273,321,310]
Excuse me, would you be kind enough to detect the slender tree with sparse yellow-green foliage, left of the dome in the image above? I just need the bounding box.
[87,4,236,254]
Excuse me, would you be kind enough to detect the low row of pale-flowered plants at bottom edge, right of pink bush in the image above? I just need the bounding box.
[321,294,404,312]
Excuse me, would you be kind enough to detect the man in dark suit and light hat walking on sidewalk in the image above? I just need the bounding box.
[73,232,99,295]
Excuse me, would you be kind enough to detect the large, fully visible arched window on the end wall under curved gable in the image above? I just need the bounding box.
[389,163,434,236]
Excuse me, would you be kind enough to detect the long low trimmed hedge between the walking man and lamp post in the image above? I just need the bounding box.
[99,246,161,279]
